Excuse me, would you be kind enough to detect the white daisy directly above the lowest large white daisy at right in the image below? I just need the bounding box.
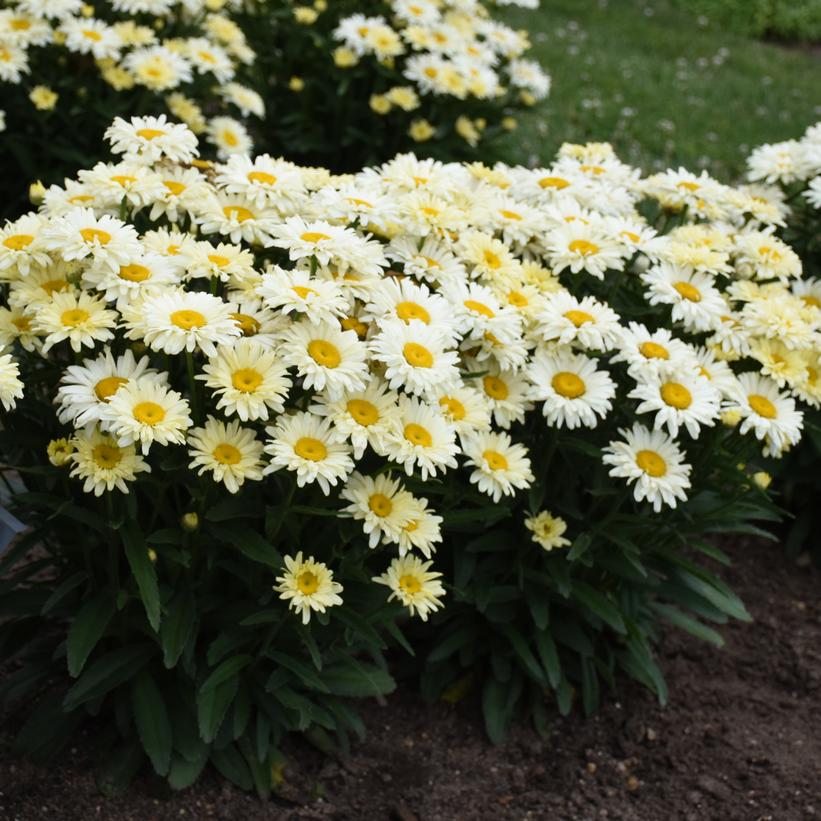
[628,367,721,439]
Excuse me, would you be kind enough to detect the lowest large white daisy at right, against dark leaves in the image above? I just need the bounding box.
[602,422,692,513]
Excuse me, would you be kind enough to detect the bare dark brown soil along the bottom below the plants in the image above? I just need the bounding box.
[0,543,821,821]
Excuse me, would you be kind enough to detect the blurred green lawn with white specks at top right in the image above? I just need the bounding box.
[496,0,821,180]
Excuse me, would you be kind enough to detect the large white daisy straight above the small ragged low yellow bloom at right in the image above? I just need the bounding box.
[528,348,616,430]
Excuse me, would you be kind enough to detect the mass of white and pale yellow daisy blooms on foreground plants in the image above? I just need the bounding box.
[0,113,821,621]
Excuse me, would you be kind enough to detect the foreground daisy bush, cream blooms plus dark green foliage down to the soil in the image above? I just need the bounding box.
[0,120,821,793]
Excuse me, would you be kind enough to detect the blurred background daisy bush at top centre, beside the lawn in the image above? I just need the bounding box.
[234,0,550,167]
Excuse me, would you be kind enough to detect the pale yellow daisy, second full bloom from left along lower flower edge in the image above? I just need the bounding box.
[188,416,262,493]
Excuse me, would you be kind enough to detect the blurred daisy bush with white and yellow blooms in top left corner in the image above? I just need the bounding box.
[0,0,265,215]
